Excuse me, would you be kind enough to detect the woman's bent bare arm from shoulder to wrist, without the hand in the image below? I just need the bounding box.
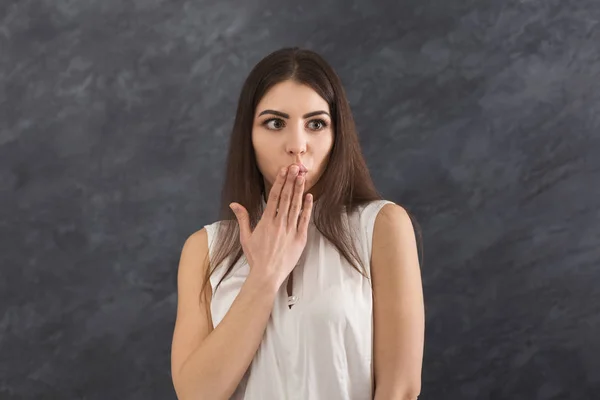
[171,229,277,400]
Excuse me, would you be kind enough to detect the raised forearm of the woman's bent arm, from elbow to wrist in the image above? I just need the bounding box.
[177,274,277,400]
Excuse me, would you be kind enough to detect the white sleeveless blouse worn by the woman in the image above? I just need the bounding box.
[205,199,392,400]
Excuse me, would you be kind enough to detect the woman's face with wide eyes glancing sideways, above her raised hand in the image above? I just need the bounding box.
[252,80,333,196]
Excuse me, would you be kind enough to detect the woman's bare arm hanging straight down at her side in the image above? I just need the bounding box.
[371,204,425,400]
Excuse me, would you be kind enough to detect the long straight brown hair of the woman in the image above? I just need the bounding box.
[203,47,420,296]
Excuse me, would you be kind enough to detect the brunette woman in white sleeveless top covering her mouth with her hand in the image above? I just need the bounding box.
[171,48,424,400]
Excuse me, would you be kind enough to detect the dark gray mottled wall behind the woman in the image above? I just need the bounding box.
[0,0,600,400]
